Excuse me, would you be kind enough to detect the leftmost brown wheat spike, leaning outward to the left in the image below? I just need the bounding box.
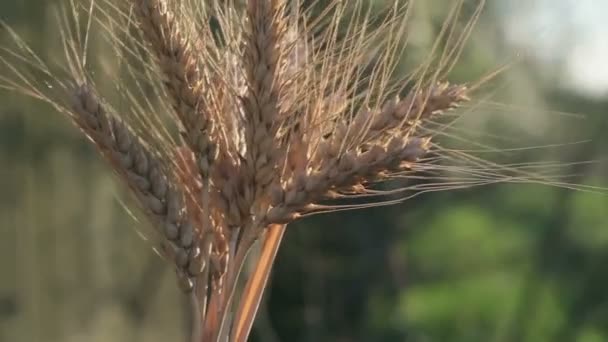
[72,85,204,288]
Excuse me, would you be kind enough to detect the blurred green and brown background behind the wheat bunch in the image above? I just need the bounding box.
[0,0,608,342]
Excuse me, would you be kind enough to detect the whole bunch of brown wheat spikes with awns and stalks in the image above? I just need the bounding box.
[0,0,604,342]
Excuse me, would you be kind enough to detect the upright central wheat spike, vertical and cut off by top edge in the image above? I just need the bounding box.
[242,0,287,211]
